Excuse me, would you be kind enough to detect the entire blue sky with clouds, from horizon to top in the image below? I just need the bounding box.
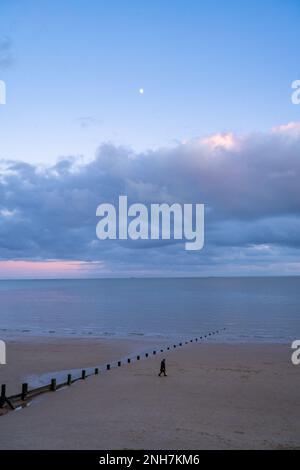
[0,0,300,278]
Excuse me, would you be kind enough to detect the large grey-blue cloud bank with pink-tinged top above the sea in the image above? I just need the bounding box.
[0,123,300,275]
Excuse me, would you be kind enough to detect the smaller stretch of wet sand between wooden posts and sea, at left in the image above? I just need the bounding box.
[0,337,161,395]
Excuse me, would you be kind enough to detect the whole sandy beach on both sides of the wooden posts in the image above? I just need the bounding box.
[0,340,300,449]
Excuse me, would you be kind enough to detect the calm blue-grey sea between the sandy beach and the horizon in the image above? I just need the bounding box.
[0,277,300,342]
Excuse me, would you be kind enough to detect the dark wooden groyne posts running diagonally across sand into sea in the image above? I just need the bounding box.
[0,328,226,409]
